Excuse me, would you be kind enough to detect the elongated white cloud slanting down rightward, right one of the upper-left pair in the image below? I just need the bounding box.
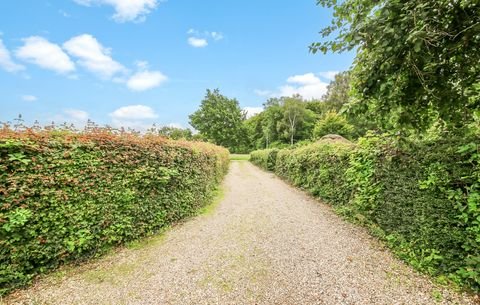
[63,34,126,79]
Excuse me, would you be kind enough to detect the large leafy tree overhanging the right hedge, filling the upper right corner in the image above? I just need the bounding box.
[310,0,480,130]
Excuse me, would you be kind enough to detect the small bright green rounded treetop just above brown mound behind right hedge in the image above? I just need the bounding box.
[313,112,354,139]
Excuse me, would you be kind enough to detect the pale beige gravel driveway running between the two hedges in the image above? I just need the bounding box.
[4,161,478,305]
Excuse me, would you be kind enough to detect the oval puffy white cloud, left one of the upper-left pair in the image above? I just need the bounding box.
[15,36,75,73]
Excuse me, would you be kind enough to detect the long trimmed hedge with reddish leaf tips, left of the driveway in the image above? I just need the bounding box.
[0,129,229,294]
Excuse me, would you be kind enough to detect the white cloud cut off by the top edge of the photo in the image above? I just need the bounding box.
[74,0,159,22]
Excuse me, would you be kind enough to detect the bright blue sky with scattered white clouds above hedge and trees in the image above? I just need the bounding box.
[0,0,353,129]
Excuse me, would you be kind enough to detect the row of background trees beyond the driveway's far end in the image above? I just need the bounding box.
[190,72,377,153]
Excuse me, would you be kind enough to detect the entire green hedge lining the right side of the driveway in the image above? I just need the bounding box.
[251,135,480,292]
